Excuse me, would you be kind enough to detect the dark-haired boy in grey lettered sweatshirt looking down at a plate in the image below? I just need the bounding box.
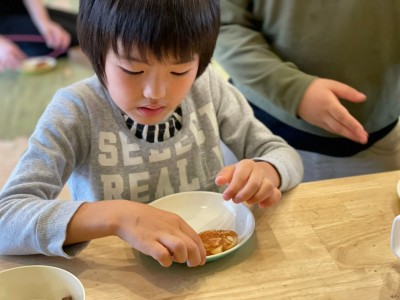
[0,0,303,266]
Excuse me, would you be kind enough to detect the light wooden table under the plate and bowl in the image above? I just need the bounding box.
[0,171,400,300]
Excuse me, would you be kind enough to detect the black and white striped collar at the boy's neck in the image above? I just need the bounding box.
[122,107,182,143]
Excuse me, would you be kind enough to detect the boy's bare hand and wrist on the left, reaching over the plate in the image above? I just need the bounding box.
[64,200,206,267]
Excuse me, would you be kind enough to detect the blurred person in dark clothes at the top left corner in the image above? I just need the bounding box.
[0,0,79,72]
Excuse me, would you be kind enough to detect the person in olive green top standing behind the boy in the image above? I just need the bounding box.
[215,0,400,181]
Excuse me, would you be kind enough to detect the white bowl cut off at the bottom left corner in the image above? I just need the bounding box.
[0,265,85,300]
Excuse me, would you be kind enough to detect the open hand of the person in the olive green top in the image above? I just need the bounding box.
[297,78,368,144]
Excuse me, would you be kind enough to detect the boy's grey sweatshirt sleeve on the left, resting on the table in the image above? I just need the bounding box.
[0,87,90,258]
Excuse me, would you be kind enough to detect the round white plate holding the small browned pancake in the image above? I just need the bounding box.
[150,191,255,262]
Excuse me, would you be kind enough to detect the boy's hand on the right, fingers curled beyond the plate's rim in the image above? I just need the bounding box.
[215,159,282,208]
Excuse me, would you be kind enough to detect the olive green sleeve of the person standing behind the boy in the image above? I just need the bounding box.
[214,0,315,116]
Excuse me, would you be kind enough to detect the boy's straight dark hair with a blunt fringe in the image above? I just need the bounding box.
[78,0,220,85]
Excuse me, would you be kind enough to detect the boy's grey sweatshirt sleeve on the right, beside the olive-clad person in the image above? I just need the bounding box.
[209,64,304,191]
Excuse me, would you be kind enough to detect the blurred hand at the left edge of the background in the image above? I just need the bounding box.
[0,36,26,72]
